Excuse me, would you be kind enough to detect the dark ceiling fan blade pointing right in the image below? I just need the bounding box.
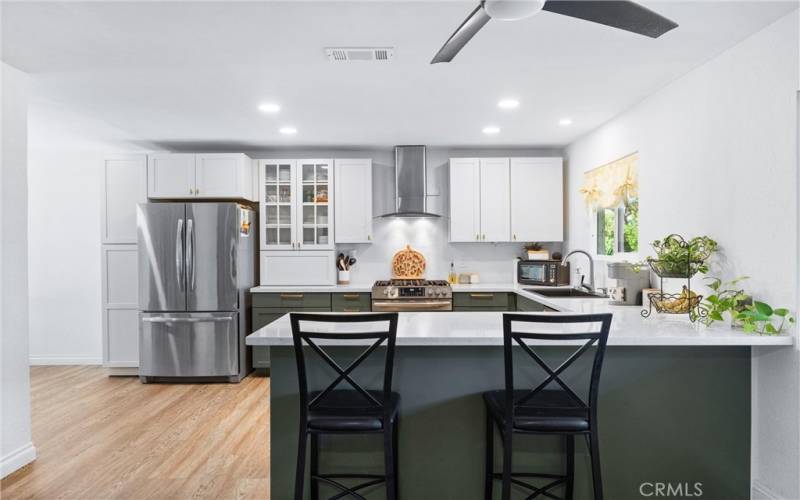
[542,0,678,38]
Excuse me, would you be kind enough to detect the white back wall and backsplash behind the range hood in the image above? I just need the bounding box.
[244,147,562,283]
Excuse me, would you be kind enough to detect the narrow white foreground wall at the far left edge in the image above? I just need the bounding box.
[0,63,36,477]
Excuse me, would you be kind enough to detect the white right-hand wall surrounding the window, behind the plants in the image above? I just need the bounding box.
[567,11,800,498]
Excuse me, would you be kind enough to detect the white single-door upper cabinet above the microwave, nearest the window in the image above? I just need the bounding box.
[511,158,564,241]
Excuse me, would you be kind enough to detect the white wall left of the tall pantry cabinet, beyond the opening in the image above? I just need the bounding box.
[28,100,151,365]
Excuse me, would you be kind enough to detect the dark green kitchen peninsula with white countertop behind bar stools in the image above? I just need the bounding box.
[247,284,793,499]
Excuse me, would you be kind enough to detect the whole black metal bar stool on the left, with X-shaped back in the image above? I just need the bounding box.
[290,313,400,500]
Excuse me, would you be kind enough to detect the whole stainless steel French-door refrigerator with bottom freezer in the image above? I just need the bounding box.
[136,203,257,383]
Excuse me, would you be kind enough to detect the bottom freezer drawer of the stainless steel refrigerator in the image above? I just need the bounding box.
[139,312,239,380]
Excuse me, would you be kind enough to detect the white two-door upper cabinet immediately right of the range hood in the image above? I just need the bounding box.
[450,158,510,242]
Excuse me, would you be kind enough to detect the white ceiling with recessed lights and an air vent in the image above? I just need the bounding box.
[2,1,797,149]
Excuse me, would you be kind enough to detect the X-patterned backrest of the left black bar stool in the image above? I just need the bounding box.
[289,313,397,418]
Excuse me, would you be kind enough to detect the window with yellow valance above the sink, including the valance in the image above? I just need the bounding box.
[581,153,639,255]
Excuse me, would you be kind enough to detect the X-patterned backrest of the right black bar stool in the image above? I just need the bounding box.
[503,313,611,425]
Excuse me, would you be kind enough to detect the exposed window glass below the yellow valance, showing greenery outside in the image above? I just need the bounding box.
[594,198,639,255]
